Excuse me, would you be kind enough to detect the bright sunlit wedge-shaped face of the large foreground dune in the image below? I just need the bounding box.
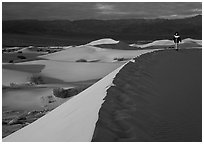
[3,50,158,142]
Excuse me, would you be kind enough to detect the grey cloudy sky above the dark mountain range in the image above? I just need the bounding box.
[2,2,202,20]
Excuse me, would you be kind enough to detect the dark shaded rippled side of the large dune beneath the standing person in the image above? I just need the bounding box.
[92,49,202,142]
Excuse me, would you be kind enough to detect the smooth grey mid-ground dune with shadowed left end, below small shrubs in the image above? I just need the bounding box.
[3,60,124,86]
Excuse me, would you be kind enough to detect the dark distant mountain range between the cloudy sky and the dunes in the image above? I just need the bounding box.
[2,15,202,45]
